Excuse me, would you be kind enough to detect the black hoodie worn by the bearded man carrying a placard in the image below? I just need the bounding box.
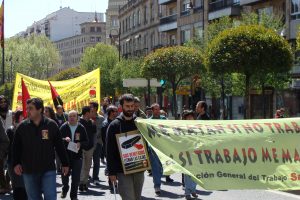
[106,113,137,176]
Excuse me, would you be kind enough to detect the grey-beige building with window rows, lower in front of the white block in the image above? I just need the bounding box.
[54,20,106,71]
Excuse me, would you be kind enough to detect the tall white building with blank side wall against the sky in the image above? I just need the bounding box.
[17,7,104,42]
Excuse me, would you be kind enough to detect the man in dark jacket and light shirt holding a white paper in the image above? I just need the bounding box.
[60,110,89,200]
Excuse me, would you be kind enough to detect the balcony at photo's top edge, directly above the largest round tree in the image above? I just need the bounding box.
[208,0,241,20]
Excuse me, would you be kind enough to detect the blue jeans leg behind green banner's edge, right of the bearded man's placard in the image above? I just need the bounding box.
[148,147,163,188]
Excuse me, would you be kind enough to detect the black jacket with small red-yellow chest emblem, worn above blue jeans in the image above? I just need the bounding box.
[12,117,69,174]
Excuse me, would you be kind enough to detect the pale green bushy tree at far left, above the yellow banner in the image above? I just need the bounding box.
[1,35,60,81]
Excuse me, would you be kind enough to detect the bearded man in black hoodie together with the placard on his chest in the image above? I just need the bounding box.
[106,94,149,200]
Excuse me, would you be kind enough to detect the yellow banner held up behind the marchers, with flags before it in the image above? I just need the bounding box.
[12,68,100,111]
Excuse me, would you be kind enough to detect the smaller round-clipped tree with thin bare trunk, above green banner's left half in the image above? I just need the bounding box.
[141,46,204,117]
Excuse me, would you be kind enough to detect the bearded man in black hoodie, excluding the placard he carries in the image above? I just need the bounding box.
[106,94,144,200]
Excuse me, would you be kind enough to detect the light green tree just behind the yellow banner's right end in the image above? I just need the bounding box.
[80,43,118,96]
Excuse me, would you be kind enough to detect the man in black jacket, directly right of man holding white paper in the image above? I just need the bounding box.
[79,106,97,192]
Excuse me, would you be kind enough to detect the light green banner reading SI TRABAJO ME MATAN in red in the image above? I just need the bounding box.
[136,118,300,190]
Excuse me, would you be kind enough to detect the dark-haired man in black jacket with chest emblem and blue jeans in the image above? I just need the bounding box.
[12,98,69,200]
